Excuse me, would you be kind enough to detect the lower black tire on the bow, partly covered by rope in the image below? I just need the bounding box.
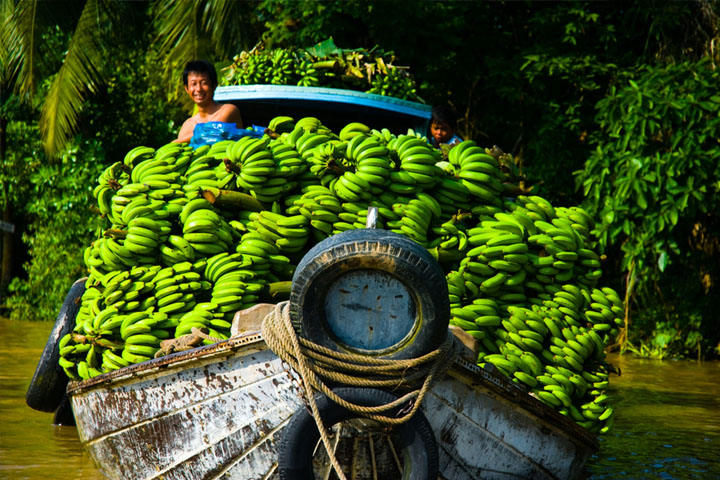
[278,387,439,480]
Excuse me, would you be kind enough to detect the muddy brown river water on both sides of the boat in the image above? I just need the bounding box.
[0,318,720,480]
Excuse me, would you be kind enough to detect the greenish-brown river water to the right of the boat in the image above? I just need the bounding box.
[587,350,720,480]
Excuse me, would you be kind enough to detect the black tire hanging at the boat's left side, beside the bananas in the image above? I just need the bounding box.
[25,278,87,413]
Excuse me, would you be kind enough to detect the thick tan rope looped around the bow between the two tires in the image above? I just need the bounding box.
[262,301,455,480]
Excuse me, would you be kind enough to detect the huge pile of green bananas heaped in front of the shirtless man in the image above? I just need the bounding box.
[66,116,624,433]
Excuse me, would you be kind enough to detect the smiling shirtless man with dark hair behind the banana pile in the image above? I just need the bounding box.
[173,60,242,142]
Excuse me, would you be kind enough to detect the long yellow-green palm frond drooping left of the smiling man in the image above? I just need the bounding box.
[40,0,112,157]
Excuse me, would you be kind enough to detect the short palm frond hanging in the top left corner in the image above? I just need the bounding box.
[0,0,40,95]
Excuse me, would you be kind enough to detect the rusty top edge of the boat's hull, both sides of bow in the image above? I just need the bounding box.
[67,332,600,452]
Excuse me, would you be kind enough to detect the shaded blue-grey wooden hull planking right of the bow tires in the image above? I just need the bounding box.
[423,379,590,479]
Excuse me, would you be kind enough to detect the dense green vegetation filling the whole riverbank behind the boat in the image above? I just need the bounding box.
[0,0,720,357]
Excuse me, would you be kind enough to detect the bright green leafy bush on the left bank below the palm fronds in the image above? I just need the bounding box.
[7,137,103,320]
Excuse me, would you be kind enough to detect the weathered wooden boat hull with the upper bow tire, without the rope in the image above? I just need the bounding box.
[54,229,598,480]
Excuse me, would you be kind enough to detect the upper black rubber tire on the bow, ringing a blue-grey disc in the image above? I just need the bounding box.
[289,229,450,359]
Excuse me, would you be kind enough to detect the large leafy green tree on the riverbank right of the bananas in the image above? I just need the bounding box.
[577,59,720,356]
